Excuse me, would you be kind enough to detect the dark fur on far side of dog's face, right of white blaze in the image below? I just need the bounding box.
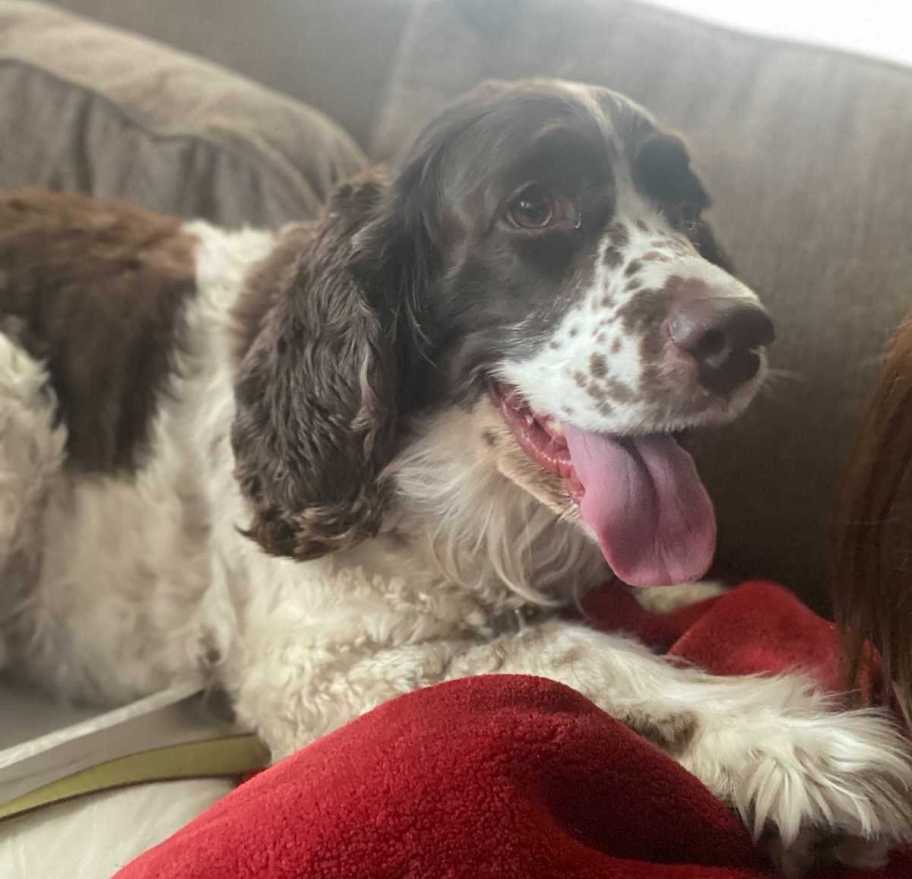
[634,131,734,274]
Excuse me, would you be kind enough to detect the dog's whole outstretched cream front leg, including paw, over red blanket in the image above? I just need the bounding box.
[235,621,912,875]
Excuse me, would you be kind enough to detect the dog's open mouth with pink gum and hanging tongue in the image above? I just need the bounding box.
[493,385,716,586]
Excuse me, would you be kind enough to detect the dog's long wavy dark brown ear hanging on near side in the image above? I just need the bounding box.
[231,176,426,560]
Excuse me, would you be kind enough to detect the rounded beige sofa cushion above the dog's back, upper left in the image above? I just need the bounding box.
[0,0,363,226]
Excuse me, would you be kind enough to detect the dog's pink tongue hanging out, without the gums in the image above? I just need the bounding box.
[564,424,716,586]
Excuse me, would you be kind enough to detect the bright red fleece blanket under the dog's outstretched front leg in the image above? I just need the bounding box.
[118,582,912,879]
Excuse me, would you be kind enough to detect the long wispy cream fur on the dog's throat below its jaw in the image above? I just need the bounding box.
[370,400,610,611]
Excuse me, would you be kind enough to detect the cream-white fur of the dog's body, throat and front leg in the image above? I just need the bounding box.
[0,224,912,869]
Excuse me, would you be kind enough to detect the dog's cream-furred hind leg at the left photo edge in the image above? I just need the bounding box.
[0,324,66,666]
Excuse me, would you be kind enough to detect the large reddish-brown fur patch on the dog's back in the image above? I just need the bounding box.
[0,189,196,472]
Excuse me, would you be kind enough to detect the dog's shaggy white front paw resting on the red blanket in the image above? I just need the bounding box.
[692,696,912,879]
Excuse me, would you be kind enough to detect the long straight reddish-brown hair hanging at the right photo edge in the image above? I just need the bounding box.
[831,322,912,721]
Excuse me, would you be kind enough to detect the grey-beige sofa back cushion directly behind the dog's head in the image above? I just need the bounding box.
[373,0,912,605]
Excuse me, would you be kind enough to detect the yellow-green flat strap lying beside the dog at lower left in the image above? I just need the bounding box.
[0,735,269,820]
